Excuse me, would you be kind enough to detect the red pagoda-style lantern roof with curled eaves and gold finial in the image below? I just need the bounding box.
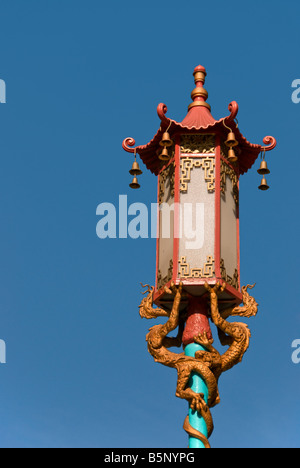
[122,65,276,175]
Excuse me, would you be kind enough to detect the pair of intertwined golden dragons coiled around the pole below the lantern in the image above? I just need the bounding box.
[139,282,258,448]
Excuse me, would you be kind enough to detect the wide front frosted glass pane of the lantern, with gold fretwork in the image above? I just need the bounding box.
[178,135,216,284]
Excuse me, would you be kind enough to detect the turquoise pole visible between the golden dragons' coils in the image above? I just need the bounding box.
[185,343,208,448]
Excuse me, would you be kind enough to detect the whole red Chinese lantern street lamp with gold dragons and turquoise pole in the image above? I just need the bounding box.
[123,66,276,448]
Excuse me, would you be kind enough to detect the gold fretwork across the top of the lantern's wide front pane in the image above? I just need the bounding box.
[180,156,216,193]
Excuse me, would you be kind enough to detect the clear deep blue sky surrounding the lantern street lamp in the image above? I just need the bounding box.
[0,0,300,448]
